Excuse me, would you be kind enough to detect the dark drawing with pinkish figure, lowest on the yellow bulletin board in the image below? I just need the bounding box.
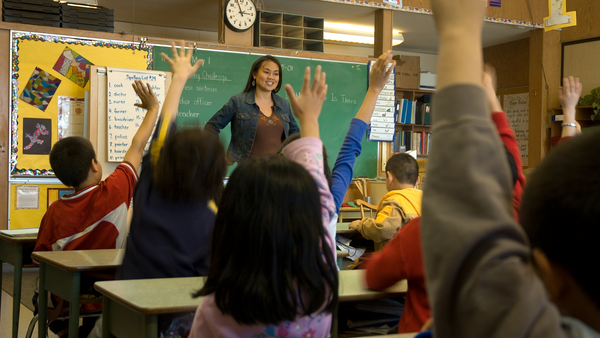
[23,118,52,155]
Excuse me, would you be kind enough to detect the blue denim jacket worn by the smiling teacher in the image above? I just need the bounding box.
[204,89,300,162]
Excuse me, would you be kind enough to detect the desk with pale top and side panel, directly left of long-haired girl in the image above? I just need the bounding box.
[94,277,206,338]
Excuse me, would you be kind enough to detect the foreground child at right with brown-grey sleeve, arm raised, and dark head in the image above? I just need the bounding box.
[422,0,600,337]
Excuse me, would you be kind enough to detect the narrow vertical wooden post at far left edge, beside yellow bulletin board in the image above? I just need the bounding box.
[0,29,12,230]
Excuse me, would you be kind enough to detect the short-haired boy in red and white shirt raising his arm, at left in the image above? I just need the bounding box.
[33,60,158,337]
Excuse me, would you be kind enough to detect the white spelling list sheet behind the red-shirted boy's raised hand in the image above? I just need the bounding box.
[106,68,166,162]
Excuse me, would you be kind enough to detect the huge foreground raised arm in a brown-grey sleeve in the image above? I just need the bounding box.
[421,0,562,338]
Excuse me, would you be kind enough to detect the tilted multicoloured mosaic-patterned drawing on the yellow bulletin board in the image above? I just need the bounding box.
[20,67,60,111]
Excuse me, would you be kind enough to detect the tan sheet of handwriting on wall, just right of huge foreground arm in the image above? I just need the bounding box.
[504,93,529,166]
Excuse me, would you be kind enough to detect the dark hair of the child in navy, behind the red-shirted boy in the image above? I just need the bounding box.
[154,127,226,202]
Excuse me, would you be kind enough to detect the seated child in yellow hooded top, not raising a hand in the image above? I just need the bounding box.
[349,154,423,250]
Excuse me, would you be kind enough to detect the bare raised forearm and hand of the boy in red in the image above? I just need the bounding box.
[123,80,158,172]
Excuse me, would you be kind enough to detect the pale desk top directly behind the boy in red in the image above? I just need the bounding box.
[31,249,125,271]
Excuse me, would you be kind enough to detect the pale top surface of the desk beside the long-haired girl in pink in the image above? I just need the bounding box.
[94,277,206,314]
